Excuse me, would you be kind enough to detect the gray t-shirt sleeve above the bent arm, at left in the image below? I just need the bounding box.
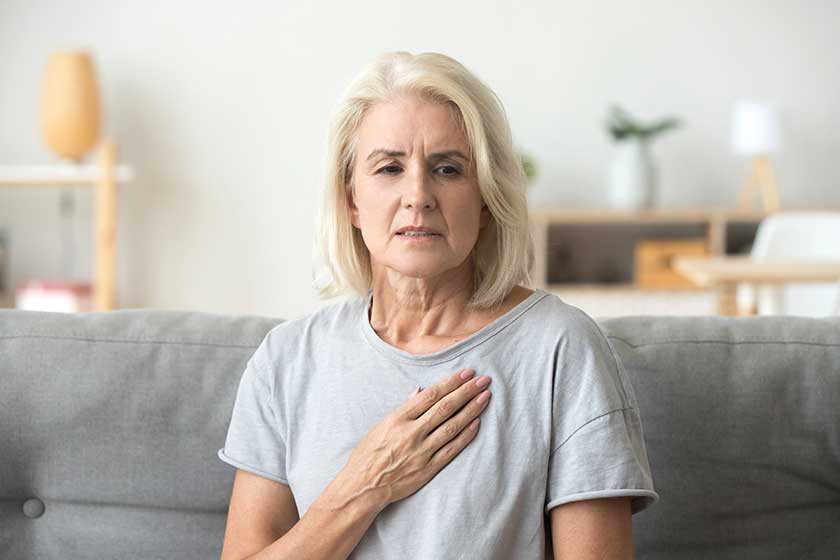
[218,342,289,485]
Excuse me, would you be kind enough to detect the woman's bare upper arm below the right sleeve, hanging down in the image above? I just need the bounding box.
[549,497,633,560]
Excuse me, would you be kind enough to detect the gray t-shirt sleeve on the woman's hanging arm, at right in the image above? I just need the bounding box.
[545,308,659,514]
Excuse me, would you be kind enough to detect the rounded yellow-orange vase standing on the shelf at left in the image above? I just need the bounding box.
[41,51,101,161]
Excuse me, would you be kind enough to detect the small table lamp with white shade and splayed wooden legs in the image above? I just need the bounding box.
[731,99,781,212]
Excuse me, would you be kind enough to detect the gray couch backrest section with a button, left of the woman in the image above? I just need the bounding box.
[0,310,281,560]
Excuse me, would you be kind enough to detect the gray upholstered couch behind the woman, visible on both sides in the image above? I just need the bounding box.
[0,310,840,560]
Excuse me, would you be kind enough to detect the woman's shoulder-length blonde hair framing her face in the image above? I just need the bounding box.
[313,51,534,309]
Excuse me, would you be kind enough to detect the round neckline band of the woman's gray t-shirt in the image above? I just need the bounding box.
[359,288,548,365]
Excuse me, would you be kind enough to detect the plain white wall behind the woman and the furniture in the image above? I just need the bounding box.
[0,0,840,318]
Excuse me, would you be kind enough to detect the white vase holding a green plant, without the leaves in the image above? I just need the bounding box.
[607,137,657,210]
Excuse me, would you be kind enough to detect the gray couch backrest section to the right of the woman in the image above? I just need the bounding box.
[599,316,840,559]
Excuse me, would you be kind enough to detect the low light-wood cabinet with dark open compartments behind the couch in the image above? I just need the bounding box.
[530,208,784,292]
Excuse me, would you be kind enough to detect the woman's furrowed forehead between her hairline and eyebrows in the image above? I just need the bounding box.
[357,96,468,152]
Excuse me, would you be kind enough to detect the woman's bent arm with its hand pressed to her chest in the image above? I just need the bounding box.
[222,370,490,560]
